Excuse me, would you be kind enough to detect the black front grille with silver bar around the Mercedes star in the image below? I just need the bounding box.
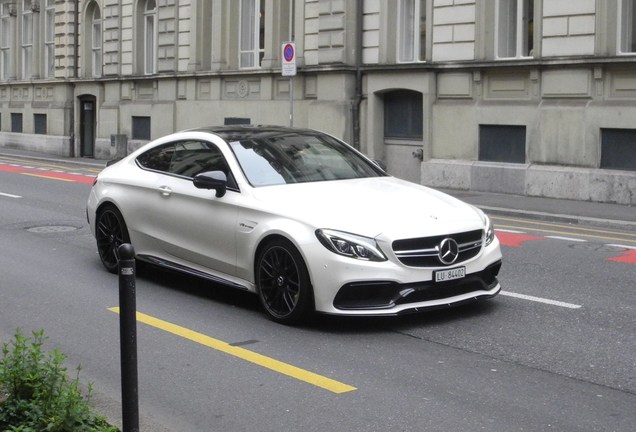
[393,230,484,267]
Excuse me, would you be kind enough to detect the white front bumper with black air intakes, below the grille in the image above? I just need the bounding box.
[301,238,502,316]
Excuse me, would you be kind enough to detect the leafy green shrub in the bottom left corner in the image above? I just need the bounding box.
[0,330,118,432]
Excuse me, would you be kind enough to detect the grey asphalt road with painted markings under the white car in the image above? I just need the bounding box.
[0,158,636,431]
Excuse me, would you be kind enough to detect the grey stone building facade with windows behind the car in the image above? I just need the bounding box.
[0,0,636,204]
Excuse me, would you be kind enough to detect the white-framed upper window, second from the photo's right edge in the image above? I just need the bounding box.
[495,0,534,58]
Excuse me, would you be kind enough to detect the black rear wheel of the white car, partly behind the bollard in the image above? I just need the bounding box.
[95,205,130,273]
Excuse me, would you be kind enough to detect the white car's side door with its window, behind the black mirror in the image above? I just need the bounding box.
[139,140,241,275]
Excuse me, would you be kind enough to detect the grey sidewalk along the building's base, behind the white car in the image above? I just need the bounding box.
[0,147,636,231]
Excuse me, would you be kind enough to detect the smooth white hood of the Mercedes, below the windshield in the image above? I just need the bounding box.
[248,177,484,239]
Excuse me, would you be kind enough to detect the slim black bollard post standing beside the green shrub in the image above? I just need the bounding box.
[118,243,139,432]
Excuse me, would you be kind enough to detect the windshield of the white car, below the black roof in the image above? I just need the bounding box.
[230,133,384,187]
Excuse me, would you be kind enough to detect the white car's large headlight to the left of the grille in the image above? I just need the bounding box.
[316,229,386,261]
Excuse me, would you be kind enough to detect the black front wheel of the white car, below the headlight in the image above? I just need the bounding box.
[255,239,314,324]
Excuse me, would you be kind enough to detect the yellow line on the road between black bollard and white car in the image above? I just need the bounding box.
[108,307,357,394]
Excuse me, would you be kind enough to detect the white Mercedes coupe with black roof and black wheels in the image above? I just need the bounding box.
[88,126,501,323]
